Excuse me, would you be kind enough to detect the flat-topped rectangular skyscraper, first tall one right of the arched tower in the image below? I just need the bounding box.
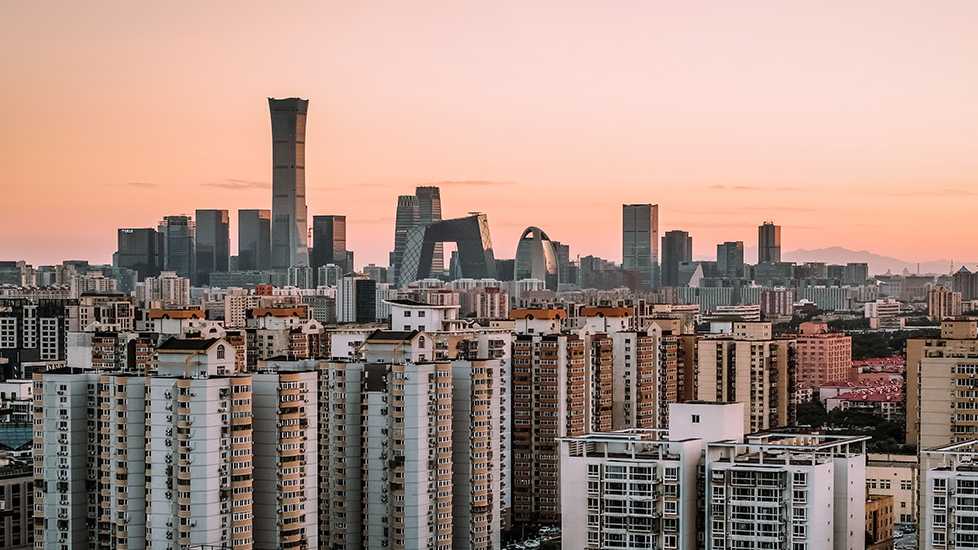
[621,204,659,289]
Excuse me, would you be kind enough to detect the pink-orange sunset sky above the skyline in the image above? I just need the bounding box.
[0,0,978,265]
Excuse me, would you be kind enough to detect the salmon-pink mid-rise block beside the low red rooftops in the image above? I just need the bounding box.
[795,322,852,390]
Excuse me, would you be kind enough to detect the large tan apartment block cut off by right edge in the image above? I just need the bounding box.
[906,320,978,449]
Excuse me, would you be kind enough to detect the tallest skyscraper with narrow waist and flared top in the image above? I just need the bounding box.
[268,97,309,269]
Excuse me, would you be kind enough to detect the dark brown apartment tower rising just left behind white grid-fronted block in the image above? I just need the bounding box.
[512,322,588,524]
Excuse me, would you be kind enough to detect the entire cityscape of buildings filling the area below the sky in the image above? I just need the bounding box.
[11,92,978,550]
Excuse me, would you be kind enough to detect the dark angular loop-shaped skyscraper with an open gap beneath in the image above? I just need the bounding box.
[397,214,496,288]
